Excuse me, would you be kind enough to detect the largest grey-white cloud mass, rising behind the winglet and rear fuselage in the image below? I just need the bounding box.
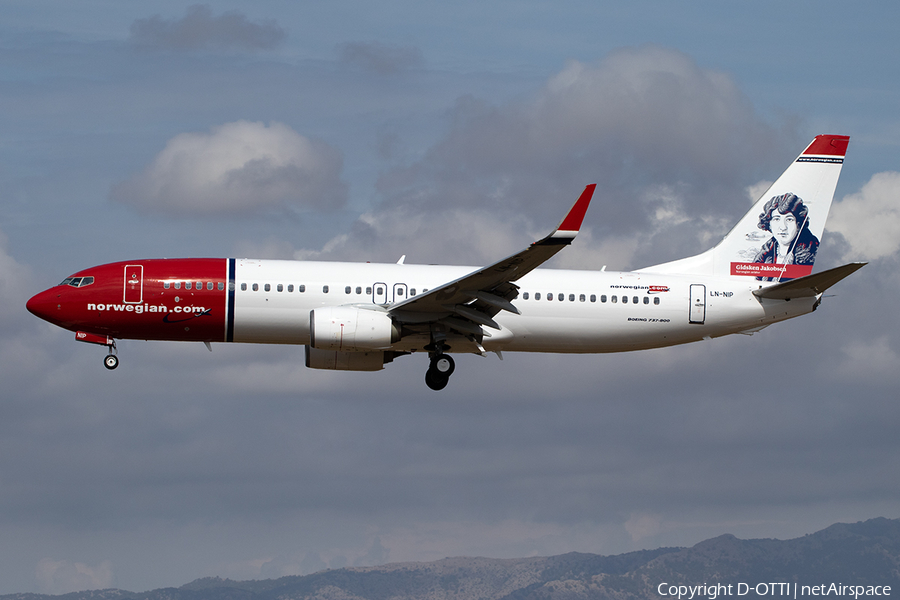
[310,47,776,268]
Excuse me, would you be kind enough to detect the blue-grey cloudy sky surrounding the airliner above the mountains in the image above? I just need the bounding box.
[0,0,900,594]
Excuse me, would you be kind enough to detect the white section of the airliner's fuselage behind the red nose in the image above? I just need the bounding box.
[234,259,817,353]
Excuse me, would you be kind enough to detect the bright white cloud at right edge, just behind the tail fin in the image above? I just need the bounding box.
[828,171,900,260]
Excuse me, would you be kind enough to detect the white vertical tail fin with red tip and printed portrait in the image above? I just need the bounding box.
[641,135,850,281]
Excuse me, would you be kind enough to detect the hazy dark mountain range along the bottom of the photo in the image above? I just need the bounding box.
[0,518,900,600]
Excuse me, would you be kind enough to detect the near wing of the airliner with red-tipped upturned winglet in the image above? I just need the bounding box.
[388,184,596,343]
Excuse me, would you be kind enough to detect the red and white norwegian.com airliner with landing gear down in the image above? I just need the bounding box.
[26,135,866,390]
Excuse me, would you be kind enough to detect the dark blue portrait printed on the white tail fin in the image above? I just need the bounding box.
[753,192,819,281]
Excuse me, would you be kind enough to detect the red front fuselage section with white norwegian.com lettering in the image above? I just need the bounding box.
[28,258,228,342]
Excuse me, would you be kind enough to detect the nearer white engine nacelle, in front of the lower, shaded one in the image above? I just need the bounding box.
[309,306,400,352]
